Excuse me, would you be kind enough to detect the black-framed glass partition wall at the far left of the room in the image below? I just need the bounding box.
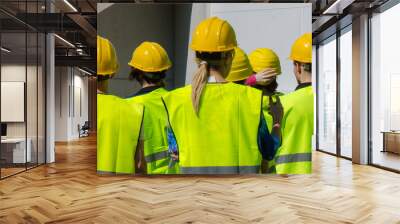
[0,1,46,179]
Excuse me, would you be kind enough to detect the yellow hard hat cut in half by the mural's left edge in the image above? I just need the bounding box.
[97,36,119,75]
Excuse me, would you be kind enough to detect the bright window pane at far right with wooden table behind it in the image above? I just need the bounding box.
[371,5,400,170]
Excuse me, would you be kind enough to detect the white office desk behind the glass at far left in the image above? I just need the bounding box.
[1,138,32,163]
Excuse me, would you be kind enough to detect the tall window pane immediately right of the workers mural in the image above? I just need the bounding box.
[318,37,337,153]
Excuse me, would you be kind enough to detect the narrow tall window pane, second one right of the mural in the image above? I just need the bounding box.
[340,29,353,158]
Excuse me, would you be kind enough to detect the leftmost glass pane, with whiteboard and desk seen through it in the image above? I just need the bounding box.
[1,32,27,177]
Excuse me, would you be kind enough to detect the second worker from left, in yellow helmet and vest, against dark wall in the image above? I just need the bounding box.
[127,42,177,174]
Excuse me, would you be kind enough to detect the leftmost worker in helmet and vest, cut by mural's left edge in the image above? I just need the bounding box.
[97,36,143,174]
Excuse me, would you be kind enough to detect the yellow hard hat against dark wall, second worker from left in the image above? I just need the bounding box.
[128,41,172,72]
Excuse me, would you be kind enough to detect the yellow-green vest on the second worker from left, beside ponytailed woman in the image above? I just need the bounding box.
[127,88,178,174]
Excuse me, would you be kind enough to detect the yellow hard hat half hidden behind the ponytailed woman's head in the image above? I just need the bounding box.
[226,47,253,82]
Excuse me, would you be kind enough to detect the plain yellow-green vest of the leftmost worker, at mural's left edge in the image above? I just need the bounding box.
[97,94,143,174]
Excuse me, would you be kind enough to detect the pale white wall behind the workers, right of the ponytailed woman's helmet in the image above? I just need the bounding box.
[210,3,312,93]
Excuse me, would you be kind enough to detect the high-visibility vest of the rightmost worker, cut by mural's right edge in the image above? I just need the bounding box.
[274,86,314,174]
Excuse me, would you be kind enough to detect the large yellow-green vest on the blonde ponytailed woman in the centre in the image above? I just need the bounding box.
[163,83,262,174]
